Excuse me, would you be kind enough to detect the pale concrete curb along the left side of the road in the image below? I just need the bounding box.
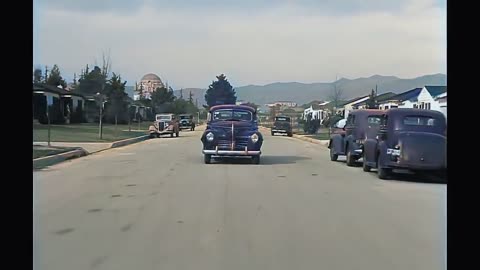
[33,135,149,170]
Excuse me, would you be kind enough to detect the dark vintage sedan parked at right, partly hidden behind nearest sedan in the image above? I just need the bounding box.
[328,109,384,166]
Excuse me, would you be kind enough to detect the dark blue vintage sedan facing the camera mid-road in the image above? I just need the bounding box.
[201,105,263,164]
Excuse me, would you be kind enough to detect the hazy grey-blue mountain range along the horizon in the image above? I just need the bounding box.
[127,73,447,107]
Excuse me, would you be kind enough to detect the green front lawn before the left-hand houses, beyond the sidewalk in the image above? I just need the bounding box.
[33,122,150,142]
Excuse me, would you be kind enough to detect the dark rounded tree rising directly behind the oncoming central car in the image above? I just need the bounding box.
[205,74,237,107]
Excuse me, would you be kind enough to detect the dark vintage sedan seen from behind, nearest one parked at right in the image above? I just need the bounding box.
[363,109,447,179]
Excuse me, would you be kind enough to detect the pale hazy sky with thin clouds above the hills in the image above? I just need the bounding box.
[33,0,446,89]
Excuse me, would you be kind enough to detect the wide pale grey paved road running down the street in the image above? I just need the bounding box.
[34,131,446,270]
